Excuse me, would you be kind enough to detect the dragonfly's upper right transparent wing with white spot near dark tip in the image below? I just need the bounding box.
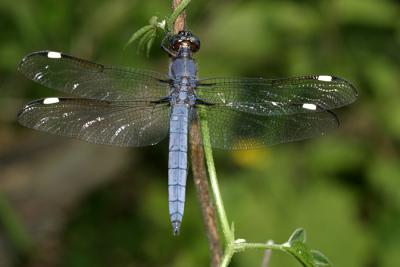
[196,75,357,115]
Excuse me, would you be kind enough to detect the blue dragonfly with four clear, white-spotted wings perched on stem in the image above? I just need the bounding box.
[18,31,357,234]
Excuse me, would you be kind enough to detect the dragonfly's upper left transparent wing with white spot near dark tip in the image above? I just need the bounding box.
[18,51,169,101]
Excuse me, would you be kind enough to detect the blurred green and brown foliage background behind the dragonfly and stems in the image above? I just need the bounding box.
[0,0,400,267]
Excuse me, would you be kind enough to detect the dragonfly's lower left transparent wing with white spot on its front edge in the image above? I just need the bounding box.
[18,98,170,147]
